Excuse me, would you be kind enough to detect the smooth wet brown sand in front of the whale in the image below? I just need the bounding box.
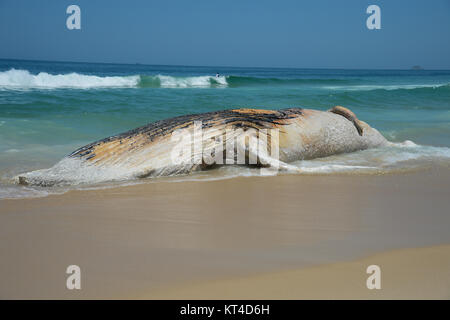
[0,168,450,299]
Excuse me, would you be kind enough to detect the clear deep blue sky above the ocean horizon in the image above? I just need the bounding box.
[0,0,450,69]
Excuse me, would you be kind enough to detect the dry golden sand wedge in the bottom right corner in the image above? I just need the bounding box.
[144,245,450,300]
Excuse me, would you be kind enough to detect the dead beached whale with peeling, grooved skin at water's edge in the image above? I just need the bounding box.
[17,106,388,186]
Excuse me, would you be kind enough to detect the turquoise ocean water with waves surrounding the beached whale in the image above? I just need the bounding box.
[0,60,450,198]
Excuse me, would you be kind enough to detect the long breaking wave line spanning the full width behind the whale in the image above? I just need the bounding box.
[0,69,450,91]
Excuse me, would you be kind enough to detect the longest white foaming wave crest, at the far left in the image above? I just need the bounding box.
[0,69,140,89]
